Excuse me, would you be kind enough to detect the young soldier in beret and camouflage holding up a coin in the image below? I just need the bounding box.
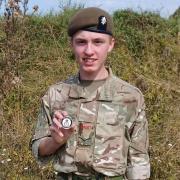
[32,8,150,180]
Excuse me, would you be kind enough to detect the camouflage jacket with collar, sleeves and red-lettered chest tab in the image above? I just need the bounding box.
[32,70,150,179]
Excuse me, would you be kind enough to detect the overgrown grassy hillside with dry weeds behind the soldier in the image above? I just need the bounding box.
[0,1,180,180]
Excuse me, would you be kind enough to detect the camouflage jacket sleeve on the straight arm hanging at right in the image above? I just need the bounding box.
[126,93,150,180]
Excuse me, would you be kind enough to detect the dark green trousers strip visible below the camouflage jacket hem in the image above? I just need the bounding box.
[56,173,124,180]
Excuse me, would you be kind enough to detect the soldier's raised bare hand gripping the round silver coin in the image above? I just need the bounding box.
[50,111,74,144]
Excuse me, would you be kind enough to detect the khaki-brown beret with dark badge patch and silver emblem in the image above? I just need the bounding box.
[68,7,113,37]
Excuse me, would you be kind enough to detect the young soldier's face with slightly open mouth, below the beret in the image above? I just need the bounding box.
[71,31,114,78]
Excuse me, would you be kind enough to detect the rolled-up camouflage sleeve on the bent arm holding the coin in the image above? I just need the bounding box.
[31,82,69,165]
